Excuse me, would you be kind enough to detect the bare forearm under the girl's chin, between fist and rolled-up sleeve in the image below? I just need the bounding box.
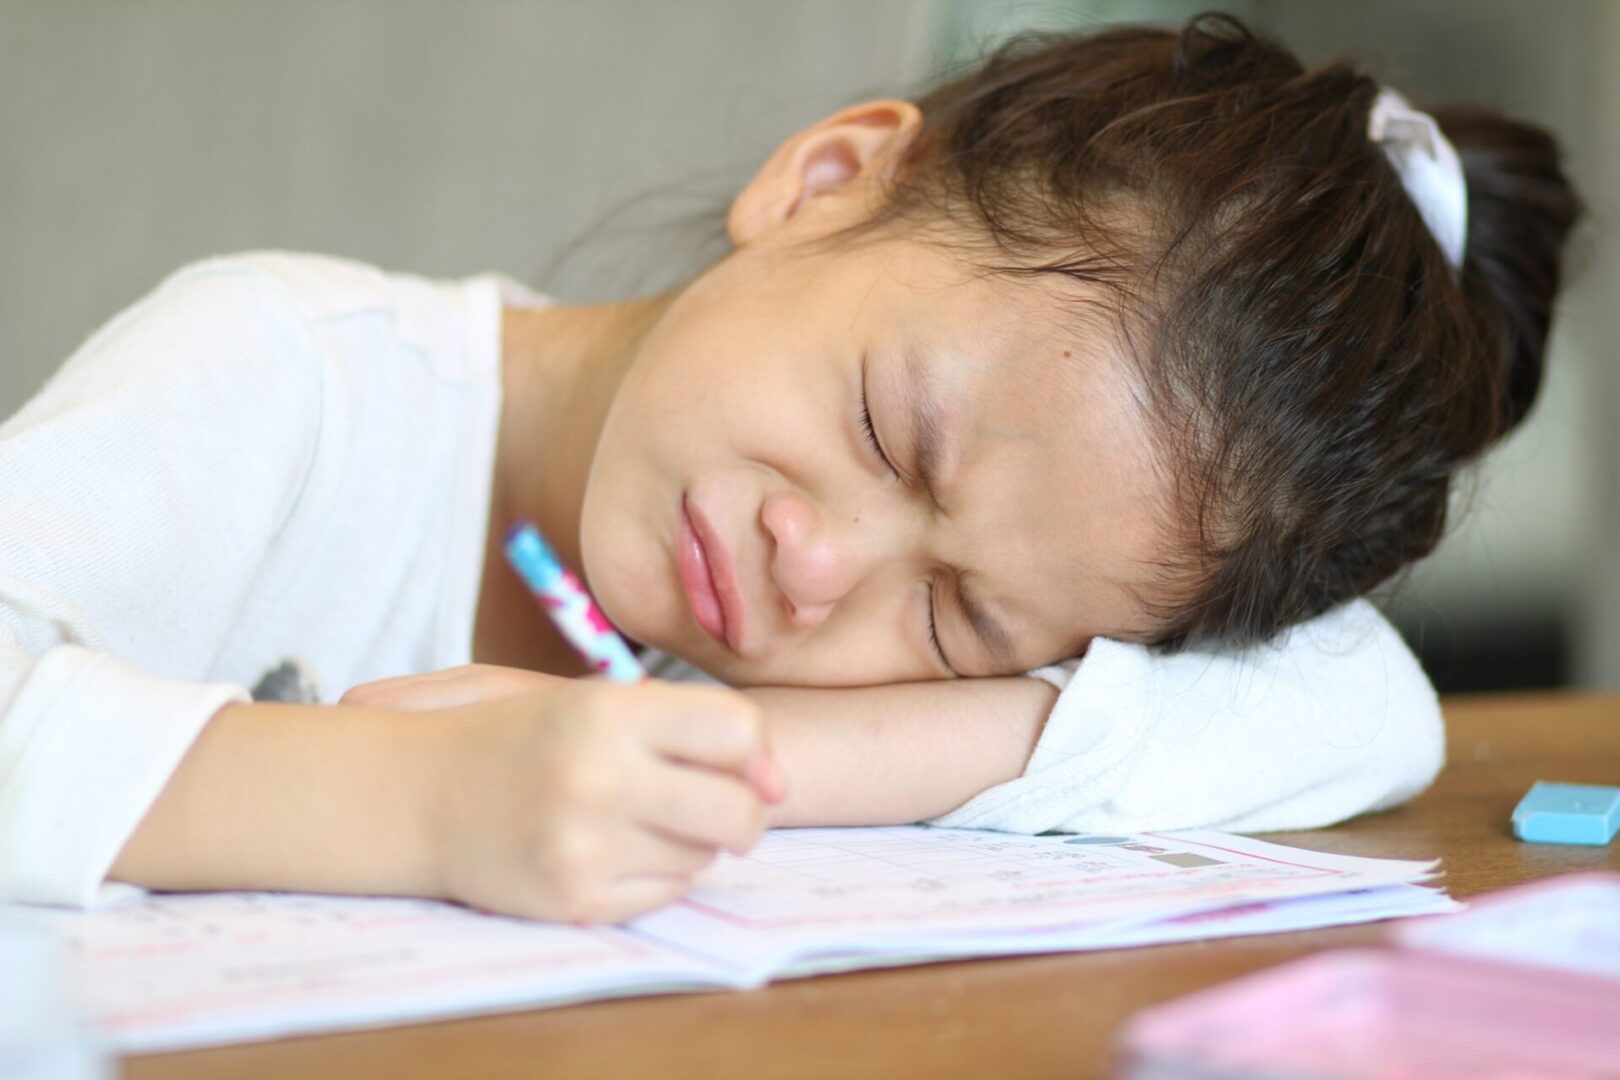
[744,677,1058,826]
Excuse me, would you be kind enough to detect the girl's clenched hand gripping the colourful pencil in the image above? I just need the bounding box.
[434,677,784,921]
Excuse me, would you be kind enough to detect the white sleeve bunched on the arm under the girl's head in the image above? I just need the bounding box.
[935,601,1445,832]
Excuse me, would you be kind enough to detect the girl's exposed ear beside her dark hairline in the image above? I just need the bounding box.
[726,99,922,248]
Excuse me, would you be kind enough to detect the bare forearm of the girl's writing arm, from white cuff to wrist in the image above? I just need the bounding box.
[109,704,452,895]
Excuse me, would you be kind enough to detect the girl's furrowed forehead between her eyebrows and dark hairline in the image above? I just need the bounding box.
[873,241,1170,662]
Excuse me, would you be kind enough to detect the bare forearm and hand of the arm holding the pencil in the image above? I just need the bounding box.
[112,680,779,921]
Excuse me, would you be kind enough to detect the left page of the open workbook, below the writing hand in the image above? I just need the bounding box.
[11,892,714,1052]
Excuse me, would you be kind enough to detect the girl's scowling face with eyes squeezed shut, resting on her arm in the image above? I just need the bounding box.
[580,102,1168,687]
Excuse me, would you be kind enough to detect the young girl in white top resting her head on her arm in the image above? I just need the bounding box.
[0,16,1576,920]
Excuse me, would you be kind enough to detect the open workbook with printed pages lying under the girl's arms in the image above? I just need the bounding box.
[5,826,1460,1052]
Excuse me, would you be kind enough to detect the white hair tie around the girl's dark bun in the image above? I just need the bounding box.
[1367,86,1468,269]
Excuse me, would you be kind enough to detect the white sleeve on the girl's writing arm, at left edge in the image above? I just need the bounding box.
[0,262,322,905]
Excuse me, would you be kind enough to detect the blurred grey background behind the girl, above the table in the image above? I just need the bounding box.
[0,0,1620,690]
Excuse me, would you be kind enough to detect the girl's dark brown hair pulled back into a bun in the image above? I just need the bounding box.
[829,15,1580,646]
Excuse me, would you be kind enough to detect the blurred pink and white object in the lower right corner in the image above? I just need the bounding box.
[1121,873,1620,1080]
